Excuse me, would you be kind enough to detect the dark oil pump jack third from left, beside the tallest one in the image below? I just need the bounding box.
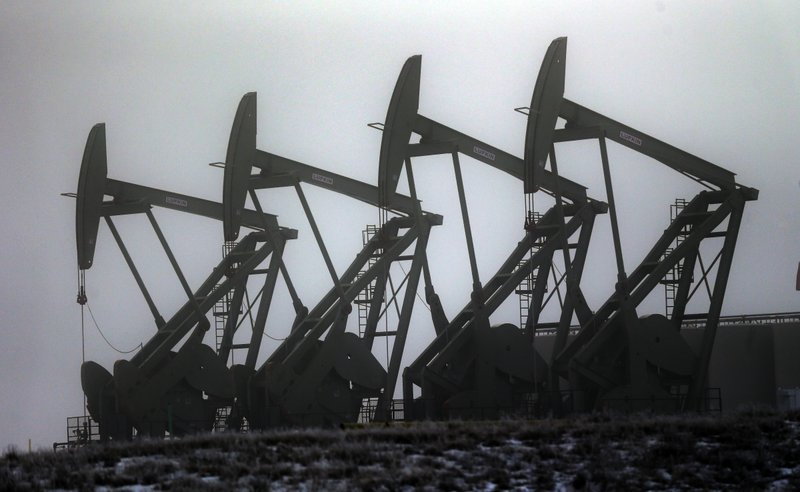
[379,56,607,419]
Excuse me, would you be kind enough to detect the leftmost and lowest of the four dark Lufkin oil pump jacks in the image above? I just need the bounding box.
[74,124,297,439]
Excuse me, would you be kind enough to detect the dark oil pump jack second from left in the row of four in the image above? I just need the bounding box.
[219,93,444,429]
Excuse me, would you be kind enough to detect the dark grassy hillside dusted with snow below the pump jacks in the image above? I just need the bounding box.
[0,412,800,490]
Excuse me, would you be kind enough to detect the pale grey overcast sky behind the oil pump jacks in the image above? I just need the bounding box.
[0,1,800,449]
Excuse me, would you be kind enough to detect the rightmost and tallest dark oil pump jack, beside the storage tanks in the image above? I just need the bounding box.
[525,38,758,411]
